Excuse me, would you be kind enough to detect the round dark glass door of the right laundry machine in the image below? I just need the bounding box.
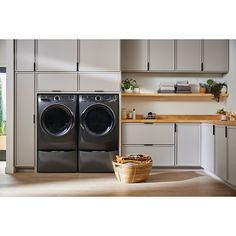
[82,104,115,136]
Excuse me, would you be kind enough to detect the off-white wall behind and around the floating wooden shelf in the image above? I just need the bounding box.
[122,40,236,114]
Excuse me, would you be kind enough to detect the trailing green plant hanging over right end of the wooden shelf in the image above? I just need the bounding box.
[199,79,228,102]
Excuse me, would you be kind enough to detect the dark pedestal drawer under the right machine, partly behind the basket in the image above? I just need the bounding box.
[79,150,119,173]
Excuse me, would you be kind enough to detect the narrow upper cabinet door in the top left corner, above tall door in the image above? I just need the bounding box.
[15,39,34,71]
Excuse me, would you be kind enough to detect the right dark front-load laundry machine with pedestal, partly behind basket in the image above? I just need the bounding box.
[78,94,119,172]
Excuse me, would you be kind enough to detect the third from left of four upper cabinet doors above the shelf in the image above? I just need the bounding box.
[176,40,201,71]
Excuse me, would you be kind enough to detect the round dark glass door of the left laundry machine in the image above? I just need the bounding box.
[41,105,74,136]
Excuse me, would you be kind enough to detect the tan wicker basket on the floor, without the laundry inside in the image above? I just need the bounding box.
[112,161,152,183]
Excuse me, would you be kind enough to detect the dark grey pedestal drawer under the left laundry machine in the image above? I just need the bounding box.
[38,151,77,173]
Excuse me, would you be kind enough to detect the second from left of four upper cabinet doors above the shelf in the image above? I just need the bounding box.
[149,40,174,71]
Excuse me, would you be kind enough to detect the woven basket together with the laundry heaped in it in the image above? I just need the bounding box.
[112,154,152,183]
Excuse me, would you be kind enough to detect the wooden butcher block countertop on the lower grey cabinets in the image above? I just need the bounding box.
[122,115,236,126]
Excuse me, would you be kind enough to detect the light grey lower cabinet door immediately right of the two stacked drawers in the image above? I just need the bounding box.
[176,124,201,166]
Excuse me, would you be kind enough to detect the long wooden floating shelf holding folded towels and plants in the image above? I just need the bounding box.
[122,93,229,101]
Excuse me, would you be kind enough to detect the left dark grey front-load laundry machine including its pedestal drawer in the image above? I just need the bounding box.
[37,94,78,172]
